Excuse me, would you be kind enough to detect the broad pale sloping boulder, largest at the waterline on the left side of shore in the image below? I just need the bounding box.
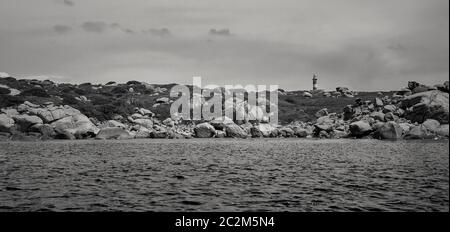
[50,114,99,138]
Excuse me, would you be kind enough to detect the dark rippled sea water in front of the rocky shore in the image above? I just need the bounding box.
[0,139,449,211]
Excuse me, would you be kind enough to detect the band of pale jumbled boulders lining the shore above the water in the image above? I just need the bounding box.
[0,77,449,141]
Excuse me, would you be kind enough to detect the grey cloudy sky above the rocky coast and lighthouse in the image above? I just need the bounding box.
[0,0,449,90]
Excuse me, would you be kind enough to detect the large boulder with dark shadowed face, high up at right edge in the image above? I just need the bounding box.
[401,90,449,124]
